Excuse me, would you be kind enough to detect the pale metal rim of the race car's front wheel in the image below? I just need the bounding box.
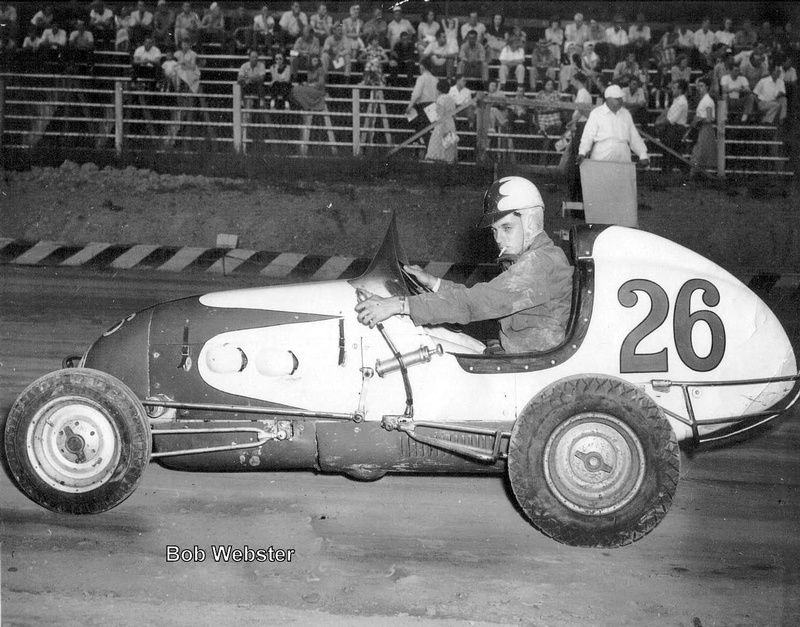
[26,396,120,493]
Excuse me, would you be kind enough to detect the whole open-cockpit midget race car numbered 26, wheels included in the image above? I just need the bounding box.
[5,218,800,547]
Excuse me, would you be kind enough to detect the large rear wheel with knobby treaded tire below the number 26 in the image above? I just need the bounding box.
[508,376,680,548]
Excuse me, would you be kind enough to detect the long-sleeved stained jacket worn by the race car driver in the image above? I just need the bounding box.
[408,232,572,353]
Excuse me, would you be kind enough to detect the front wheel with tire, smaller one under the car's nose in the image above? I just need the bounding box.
[5,368,152,514]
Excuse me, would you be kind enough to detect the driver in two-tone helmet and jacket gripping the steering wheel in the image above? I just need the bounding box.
[356,176,572,353]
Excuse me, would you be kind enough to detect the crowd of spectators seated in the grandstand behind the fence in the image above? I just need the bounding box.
[0,0,800,164]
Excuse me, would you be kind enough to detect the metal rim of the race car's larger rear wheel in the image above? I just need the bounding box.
[544,412,645,516]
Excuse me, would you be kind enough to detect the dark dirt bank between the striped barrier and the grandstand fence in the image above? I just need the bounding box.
[0,161,800,271]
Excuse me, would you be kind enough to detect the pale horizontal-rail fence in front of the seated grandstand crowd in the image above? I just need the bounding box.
[0,73,792,176]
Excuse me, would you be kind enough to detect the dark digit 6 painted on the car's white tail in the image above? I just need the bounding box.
[673,279,725,372]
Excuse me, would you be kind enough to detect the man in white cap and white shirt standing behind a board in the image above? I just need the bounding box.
[578,85,650,166]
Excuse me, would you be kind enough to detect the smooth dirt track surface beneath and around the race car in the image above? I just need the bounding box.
[0,266,800,627]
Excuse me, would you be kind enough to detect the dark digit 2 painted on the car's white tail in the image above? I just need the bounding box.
[617,279,669,372]
